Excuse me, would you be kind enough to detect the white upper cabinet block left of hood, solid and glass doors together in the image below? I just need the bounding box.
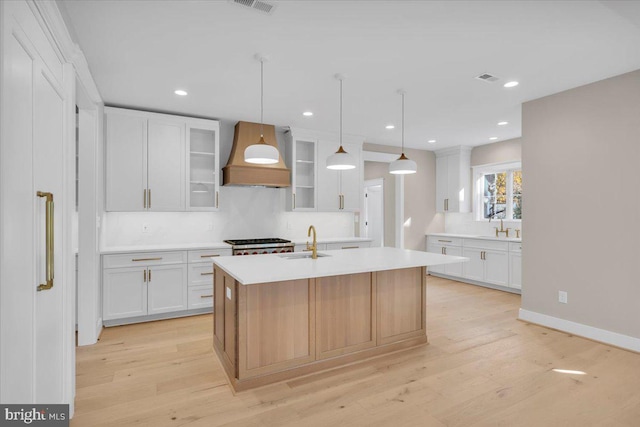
[105,107,219,212]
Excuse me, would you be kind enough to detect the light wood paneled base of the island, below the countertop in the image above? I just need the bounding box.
[213,265,427,391]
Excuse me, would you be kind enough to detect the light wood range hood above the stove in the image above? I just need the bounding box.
[222,122,291,187]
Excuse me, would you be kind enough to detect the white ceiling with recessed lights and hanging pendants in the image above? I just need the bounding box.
[58,0,640,150]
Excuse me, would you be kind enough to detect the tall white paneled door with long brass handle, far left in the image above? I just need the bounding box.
[0,1,74,403]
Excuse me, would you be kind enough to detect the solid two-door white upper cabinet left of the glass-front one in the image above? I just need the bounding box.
[105,107,185,211]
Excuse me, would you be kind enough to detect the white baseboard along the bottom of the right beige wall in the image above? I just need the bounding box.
[518,308,640,353]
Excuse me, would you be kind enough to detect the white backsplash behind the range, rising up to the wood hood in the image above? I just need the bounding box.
[101,187,357,247]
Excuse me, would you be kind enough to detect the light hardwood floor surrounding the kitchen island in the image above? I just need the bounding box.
[71,276,640,427]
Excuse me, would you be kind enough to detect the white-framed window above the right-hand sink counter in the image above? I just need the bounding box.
[473,162,522,220]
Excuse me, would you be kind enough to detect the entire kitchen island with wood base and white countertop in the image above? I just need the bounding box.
[213,248,466,391]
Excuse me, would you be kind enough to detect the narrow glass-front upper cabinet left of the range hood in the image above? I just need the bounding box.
[186,119,220,211]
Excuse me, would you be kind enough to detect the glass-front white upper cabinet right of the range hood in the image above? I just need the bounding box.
[285,130,318,212]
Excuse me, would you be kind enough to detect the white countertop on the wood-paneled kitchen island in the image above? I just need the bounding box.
[213,248,469,285]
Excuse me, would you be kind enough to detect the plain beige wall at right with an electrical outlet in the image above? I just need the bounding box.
[522,70,640,351]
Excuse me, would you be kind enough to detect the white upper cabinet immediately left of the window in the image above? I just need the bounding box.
[435,147,472,212]
